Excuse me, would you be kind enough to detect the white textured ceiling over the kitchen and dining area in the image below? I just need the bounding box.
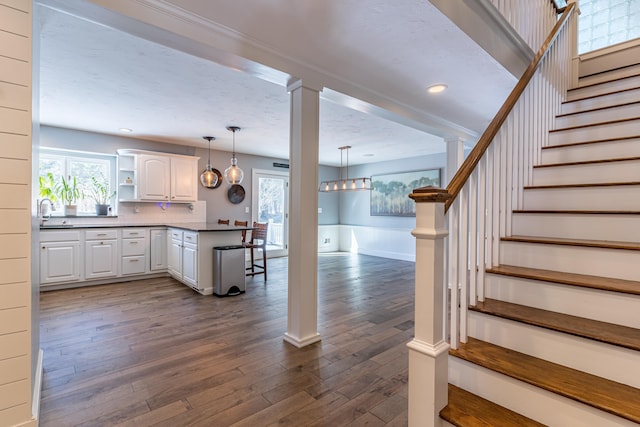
[38,0,515,165]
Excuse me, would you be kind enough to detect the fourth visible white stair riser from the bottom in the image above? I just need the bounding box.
[499,241,640,280]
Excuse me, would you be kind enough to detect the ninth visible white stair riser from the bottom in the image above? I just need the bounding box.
[549,119,640,145]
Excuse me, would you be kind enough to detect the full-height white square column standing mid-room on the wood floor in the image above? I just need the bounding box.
[284,80,321,347]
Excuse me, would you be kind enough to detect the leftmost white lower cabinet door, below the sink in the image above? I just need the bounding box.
[40,241,80,284]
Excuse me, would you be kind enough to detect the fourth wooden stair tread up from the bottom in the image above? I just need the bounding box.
[487,265,640,295]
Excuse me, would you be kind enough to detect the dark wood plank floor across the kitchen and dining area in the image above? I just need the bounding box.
[40,254,414,427]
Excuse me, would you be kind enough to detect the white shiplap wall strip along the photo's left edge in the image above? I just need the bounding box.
[0,0,35,427]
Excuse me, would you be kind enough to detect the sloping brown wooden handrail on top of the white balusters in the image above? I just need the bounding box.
[438,3,575,212]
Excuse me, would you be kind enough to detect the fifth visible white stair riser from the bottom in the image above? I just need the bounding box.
[511,213,640,242]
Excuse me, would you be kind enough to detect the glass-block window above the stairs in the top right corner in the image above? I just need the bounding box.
[578,0,640,53]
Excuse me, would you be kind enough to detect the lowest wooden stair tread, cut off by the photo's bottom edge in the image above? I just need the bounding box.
[440,384,544,427]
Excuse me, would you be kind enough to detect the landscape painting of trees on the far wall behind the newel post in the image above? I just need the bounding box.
[371,169,440,216]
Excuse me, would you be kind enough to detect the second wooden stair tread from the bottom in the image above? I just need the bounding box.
[449,337,640,423]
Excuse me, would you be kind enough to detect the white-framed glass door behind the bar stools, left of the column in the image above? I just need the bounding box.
[251,169,289,257]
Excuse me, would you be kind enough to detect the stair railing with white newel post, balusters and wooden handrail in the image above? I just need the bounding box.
[407,3,577,426]
